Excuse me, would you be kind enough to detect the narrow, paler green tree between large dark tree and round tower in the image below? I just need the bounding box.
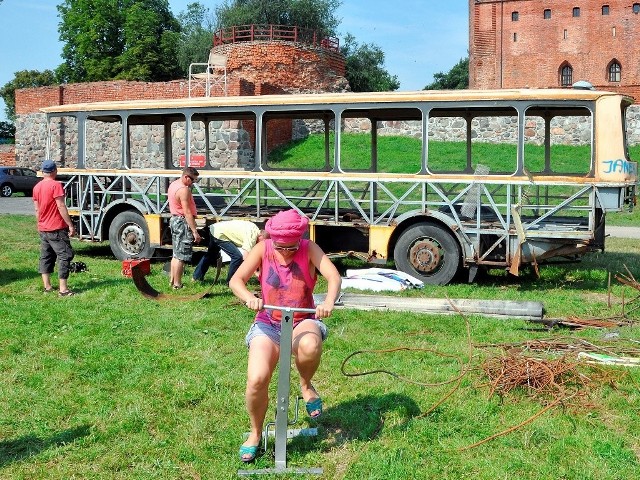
[178,2,215,72]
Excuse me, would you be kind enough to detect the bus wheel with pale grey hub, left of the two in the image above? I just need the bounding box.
[109,211,155,260]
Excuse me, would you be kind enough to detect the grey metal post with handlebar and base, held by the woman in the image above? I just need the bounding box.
[238,305,323,475]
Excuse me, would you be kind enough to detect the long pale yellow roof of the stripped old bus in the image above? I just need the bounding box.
[40,88,633,114]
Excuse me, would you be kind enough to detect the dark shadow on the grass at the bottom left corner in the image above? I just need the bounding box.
[0,425,91,467]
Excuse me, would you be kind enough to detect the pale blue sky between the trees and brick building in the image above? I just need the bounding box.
[0,0,469,121]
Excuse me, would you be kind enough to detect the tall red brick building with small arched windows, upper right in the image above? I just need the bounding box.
[469,0,640,99]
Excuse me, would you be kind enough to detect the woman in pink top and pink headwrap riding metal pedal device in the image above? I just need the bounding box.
[229,210,341,462]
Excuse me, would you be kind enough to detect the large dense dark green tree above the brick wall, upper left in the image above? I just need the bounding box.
[57,0,182,82]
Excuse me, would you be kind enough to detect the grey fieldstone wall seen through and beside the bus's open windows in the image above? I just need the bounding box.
[12,105,640,168]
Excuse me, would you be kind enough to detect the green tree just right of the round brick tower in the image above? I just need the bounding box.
[340,33,400,92]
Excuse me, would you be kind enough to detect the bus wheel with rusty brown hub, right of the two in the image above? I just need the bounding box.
[393,223,460,285]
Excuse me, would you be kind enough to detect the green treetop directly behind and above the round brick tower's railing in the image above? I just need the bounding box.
[215,0,342,36]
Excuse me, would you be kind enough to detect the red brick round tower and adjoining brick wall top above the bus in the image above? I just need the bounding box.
[16,41,349,115]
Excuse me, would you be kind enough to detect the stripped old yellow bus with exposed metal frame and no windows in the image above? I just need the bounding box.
[43,89,637,284]
